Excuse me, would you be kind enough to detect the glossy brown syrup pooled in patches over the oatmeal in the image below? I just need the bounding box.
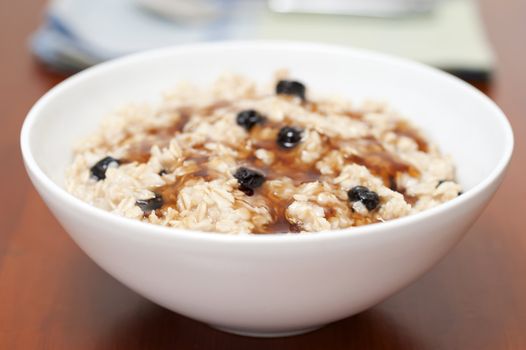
[121,101,427,234]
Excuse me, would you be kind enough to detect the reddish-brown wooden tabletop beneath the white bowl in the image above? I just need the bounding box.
[0,0,526,349]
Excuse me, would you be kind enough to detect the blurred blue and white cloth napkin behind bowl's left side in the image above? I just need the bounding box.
[31,0,260,71]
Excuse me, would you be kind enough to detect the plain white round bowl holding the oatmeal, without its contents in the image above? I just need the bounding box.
[21,42,513,336]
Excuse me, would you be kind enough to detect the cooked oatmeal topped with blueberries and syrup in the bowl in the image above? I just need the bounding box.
[66,75,461,233]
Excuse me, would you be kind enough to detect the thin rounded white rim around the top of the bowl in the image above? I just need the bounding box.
[20,40,514,244]
